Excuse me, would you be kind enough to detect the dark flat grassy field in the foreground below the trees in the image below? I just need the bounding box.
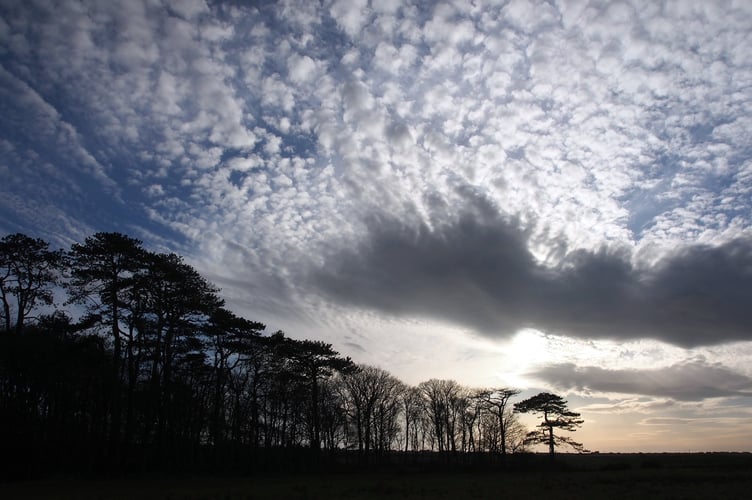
[0,453,752,500]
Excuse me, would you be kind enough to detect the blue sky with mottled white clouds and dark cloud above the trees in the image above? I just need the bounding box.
[0,0,752,452]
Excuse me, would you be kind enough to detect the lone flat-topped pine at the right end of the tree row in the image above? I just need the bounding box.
[514,392,585,457]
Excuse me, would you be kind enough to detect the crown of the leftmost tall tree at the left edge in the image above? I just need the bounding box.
[0,233,62,333]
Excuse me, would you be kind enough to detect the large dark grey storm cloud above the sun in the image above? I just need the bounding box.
[314,200,752,347]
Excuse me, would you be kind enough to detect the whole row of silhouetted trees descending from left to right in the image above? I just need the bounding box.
[0,233,582,477]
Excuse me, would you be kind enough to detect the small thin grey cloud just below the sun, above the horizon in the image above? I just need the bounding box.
[530,359,752,401]
